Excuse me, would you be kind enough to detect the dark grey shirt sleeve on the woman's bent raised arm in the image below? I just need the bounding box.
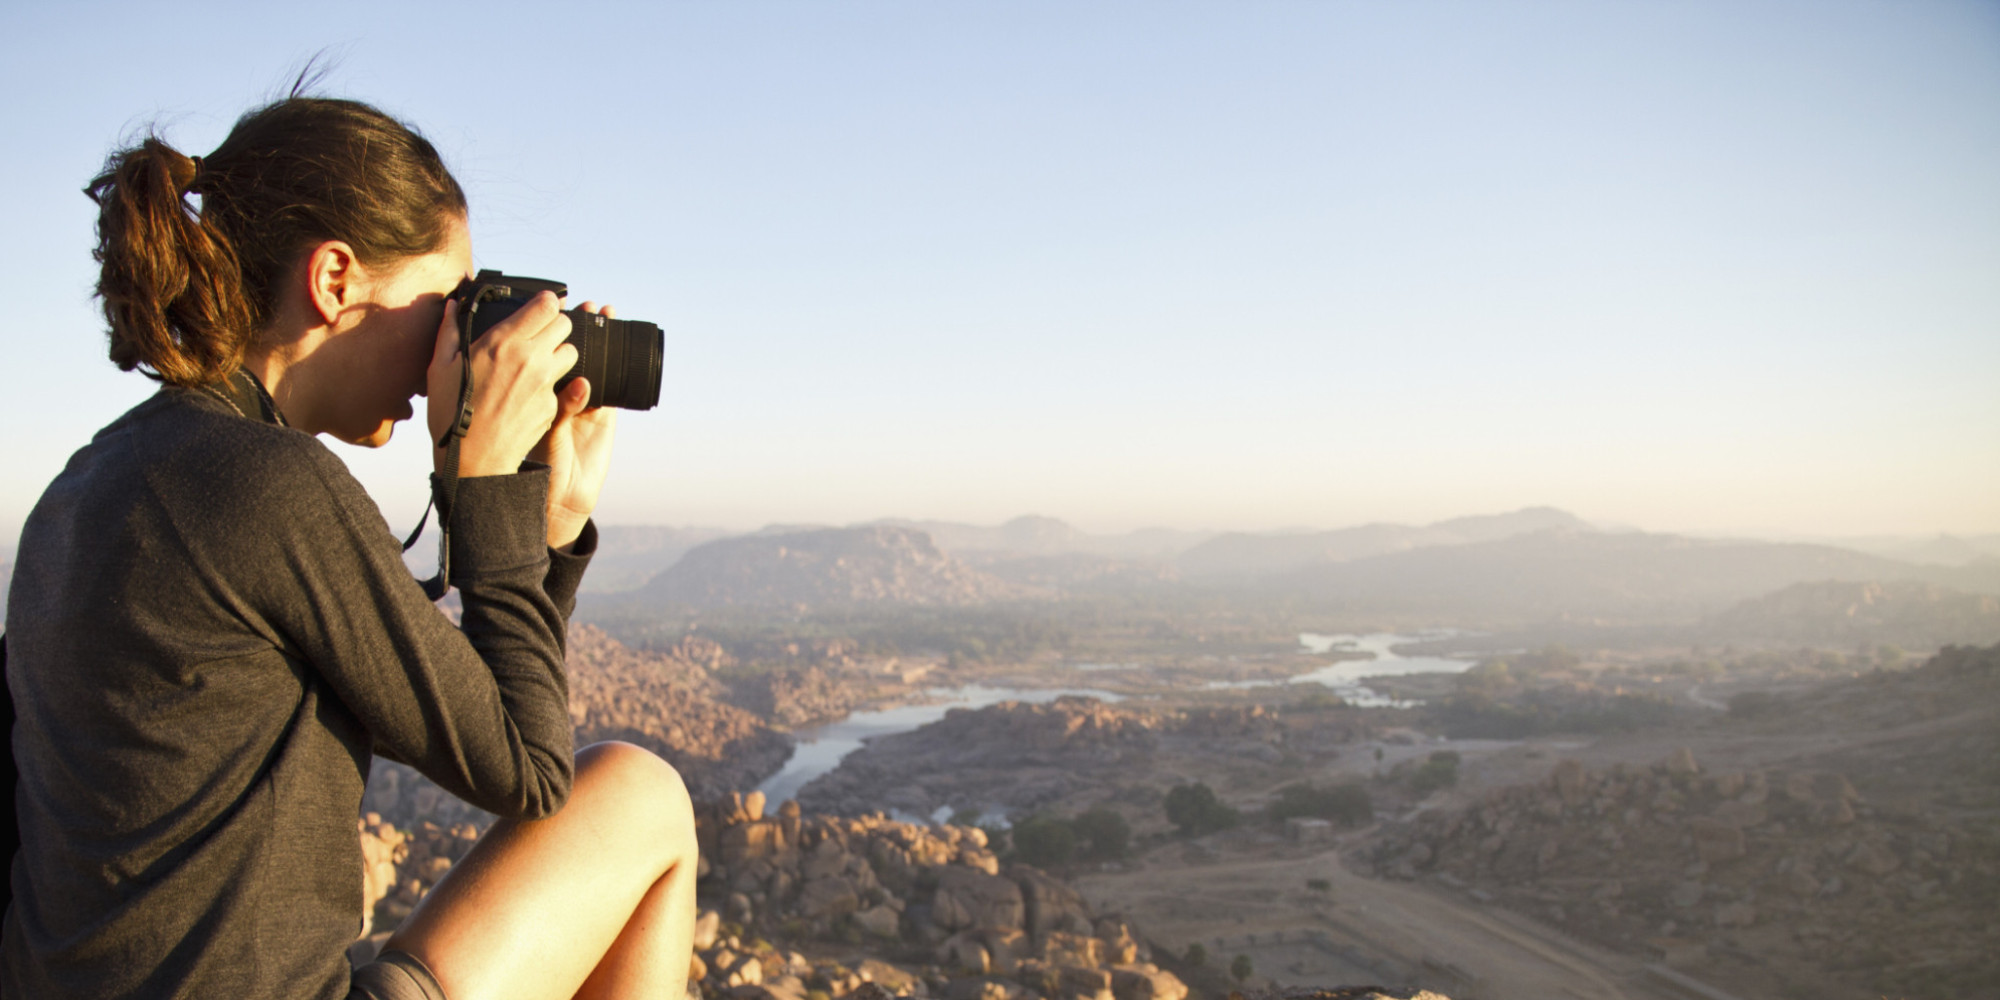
[203,436,596,818]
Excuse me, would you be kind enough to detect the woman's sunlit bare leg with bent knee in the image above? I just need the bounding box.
[384,744,696,1000]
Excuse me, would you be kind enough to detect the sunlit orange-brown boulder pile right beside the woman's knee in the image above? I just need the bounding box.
[696,794,1188,1000]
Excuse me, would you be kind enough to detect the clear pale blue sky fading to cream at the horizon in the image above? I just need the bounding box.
[0,0,2000,546]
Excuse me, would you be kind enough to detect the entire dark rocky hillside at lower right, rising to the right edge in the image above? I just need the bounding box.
[1356,648,2000,998]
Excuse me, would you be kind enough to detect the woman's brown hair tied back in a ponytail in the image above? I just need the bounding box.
[84,96,466,386]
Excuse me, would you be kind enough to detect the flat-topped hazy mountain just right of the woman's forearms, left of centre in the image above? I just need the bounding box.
[636,526,1030,608]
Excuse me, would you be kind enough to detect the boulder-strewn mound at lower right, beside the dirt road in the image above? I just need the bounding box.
[1358,750,2000,996]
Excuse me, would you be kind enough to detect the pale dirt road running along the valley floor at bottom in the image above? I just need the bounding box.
[1076,846,1664,1000]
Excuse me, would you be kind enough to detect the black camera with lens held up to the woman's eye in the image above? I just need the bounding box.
[452,270,666,410]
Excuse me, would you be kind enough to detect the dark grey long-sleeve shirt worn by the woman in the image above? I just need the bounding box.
[0,388,594,1000]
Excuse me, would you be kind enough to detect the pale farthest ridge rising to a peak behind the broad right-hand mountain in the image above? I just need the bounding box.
[1176,506,1590,580]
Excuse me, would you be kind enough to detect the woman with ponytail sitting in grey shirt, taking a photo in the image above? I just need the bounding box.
[0,94,696,1000]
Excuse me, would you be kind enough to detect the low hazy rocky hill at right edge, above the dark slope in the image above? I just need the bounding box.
[1700,580,2000,650]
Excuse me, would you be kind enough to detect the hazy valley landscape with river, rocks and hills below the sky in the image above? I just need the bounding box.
[364,510,2000,1000]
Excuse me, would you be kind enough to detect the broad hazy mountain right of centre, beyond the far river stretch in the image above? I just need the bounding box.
[1266,530,1952,624]
